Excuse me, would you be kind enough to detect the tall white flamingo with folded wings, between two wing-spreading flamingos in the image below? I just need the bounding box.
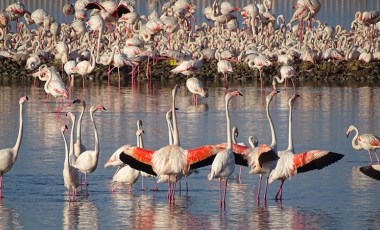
[208,91,243,208]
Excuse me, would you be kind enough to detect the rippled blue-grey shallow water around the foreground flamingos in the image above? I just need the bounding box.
[0,78,380,229]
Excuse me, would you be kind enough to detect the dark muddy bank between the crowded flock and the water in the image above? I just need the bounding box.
[0,60,380,82]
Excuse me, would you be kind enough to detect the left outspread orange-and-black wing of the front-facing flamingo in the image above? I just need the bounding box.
[120,146,157,176]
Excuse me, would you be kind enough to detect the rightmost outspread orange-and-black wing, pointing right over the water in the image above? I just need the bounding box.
[293,150,344,173]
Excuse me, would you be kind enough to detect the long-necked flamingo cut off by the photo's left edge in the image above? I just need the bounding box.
[0,96,28,199]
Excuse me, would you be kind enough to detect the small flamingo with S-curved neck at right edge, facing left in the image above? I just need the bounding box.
[346,125,380,163]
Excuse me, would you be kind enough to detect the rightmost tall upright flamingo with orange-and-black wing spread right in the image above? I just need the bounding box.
[269,94,344,200]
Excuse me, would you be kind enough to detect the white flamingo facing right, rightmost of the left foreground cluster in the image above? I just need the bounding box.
[74,105,106,196]
